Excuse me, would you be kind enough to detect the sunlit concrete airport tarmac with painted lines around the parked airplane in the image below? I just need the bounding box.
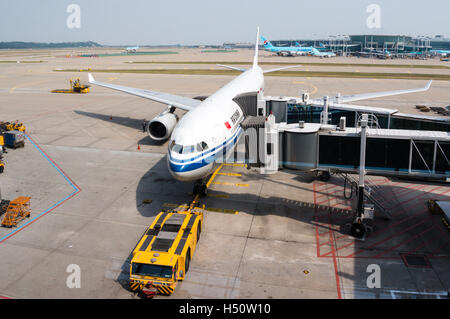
[0,49,450,299]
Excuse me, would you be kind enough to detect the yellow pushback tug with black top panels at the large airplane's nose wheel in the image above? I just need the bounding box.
[130,196,203,297]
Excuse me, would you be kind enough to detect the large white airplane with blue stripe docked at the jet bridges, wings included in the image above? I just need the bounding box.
[88,28,432,195]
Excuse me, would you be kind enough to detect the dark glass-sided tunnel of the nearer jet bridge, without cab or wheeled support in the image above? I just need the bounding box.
[272,123,450,180]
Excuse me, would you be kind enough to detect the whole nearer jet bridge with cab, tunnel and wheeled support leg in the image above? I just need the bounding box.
[237,113,450,238]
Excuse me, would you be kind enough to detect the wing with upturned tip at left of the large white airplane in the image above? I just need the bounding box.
[88,73,202,111]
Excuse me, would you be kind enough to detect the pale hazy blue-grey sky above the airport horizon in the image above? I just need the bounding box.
[0,0,450,45]
